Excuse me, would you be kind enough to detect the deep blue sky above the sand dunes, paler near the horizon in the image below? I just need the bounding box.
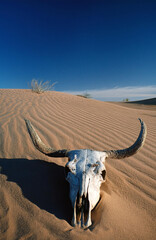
[0,0,156,100]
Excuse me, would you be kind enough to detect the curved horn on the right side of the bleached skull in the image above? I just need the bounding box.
[104,118,147,159]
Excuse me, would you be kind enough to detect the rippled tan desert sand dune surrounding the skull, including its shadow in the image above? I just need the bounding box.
[0,89,156,240]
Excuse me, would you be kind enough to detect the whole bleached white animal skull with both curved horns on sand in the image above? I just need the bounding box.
[25,119,147,227]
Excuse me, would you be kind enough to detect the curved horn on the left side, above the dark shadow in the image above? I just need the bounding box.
[25,119,68,157]
